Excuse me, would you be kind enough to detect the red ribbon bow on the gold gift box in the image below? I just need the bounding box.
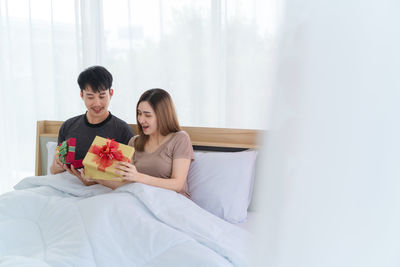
[89,138,129,172]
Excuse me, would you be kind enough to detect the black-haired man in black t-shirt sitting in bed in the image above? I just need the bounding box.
[50,66,133,185]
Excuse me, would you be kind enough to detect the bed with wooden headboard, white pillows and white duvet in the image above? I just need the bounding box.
[0,121,260,266]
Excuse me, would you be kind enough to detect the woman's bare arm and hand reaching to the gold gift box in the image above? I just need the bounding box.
[116,159,191,193]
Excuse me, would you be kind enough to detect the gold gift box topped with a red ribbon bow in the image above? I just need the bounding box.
[83,136,135,180]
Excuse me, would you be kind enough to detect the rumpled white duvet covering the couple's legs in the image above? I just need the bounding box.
[0,173,249,267]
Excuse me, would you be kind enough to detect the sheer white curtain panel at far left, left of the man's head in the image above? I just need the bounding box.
[0,0,83,192]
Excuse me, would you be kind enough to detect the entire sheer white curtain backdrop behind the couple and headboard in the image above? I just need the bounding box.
[0,0,276,192]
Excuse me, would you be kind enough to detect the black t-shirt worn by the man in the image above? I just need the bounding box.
[58,112,133,160]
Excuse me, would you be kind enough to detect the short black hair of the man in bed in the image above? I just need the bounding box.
[78,66,112,92]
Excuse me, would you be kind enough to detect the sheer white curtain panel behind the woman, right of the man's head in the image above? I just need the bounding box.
[102,0,274,128]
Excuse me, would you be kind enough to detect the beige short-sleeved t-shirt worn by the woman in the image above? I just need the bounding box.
[128,131,194,197]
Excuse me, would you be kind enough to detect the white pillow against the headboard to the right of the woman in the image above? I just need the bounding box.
[188,150,257,223]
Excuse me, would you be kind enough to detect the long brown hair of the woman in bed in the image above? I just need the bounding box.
[133,88,181,151]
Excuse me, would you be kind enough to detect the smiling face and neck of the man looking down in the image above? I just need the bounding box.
[81,85,114,121]
